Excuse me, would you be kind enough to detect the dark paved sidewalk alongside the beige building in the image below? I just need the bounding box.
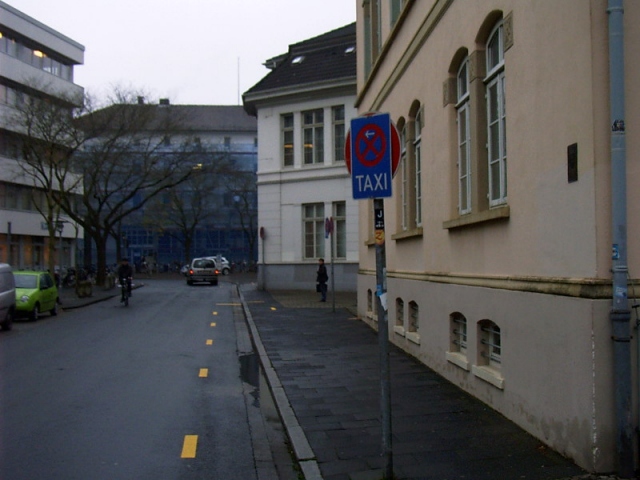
[240,285,617,480]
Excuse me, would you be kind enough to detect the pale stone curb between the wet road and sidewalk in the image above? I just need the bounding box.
[236,284,323,480]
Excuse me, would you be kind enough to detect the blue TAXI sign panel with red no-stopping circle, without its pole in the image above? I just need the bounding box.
[345,113,400,200]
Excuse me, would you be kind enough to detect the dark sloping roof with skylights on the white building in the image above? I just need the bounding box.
[243,22,356,114]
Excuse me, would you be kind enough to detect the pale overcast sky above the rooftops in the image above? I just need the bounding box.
[4,0,357,105]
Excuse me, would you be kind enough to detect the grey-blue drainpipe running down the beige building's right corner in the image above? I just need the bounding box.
[607,0,634,478]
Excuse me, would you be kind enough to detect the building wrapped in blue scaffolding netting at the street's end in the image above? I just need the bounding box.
[117,99,257,268]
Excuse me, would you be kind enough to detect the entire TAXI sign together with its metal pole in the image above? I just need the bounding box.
[345,113,400,480]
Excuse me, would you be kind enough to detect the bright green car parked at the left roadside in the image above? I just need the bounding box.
[13,271,58,321]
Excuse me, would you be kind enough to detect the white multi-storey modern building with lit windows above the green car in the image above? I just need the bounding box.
[0,1,84,268]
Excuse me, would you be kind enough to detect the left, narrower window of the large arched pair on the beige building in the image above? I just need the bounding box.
[456,59,471,214]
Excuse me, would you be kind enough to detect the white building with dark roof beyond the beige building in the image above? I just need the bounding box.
[243,24,358,291]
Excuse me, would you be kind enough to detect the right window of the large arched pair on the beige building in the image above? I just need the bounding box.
[485,22,507,206]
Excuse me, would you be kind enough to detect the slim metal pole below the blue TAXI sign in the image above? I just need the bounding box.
[373,198,393,480]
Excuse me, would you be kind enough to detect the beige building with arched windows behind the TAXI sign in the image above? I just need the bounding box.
[356,0,640,472]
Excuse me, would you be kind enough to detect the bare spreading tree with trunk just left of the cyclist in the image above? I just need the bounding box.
[60,90,193,284]
